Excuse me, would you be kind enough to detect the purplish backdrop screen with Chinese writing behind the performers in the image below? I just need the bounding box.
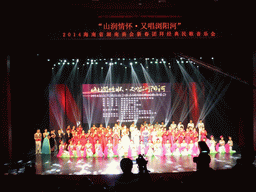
[83,83,171,124]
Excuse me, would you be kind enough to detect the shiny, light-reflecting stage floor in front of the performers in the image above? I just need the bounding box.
[35,153,241,175]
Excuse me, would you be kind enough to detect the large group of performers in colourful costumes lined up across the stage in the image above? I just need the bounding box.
[34,120,235,157]
